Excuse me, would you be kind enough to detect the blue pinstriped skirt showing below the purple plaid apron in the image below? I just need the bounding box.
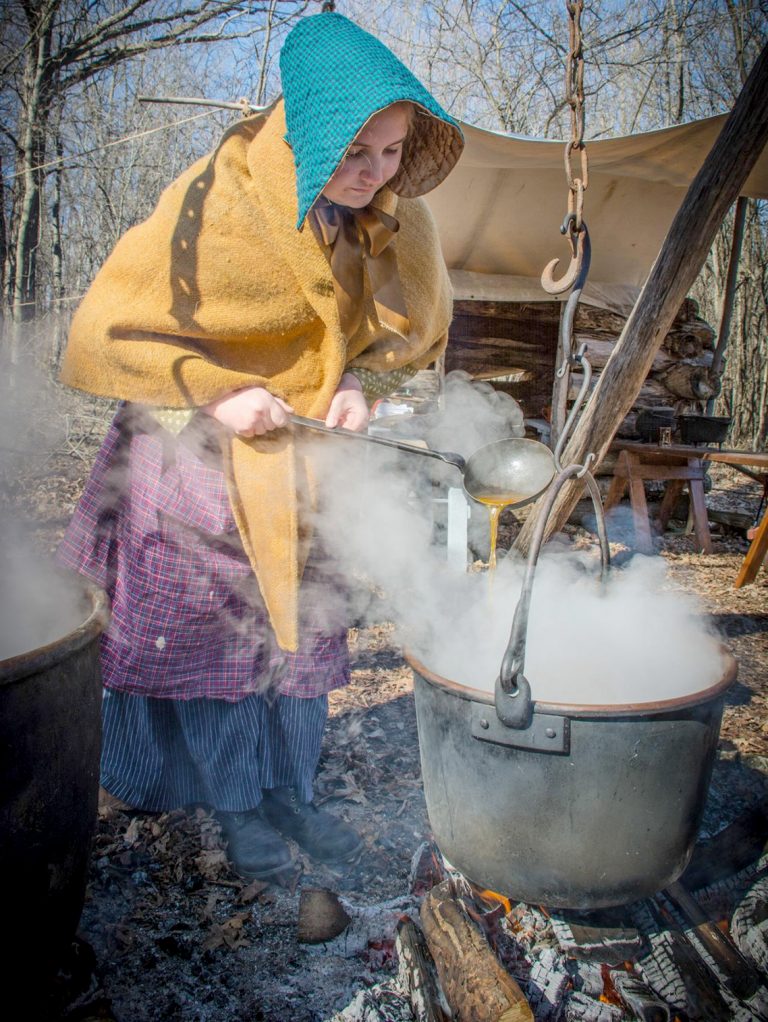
[101,689,328,812]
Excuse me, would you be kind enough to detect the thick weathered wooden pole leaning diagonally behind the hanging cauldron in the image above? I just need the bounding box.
[514,39,768,555]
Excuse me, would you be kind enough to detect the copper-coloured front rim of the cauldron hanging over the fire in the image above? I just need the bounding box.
[404,644,738,717]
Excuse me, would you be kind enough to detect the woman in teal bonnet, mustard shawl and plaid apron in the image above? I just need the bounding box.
[59,13,463,878]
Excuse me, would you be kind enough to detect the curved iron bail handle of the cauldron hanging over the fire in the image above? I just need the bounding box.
[495,465,611,729]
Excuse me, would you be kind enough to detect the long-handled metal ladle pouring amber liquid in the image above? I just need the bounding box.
[290,415,555,508]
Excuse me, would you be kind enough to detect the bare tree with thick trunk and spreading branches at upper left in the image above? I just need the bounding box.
[0,0,307,355]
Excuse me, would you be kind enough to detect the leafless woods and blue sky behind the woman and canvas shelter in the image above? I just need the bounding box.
[0,0,768,450]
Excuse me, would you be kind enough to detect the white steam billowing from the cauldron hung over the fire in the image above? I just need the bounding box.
[312,379,723,705]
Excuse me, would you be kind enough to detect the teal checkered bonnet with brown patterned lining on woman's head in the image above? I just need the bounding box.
[280,11,464,228]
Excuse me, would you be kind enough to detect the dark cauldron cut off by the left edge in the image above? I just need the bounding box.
[0,584,107,981]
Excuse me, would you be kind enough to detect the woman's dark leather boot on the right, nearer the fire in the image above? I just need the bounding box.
[262,788,363,863]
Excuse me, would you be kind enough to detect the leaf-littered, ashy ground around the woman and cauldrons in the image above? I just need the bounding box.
[4,416,768,1022]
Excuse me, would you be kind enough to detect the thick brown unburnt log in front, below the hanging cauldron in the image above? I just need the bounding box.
[421,881,534,1022]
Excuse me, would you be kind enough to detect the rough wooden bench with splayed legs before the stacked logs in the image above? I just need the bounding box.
[605,440,768,589]
